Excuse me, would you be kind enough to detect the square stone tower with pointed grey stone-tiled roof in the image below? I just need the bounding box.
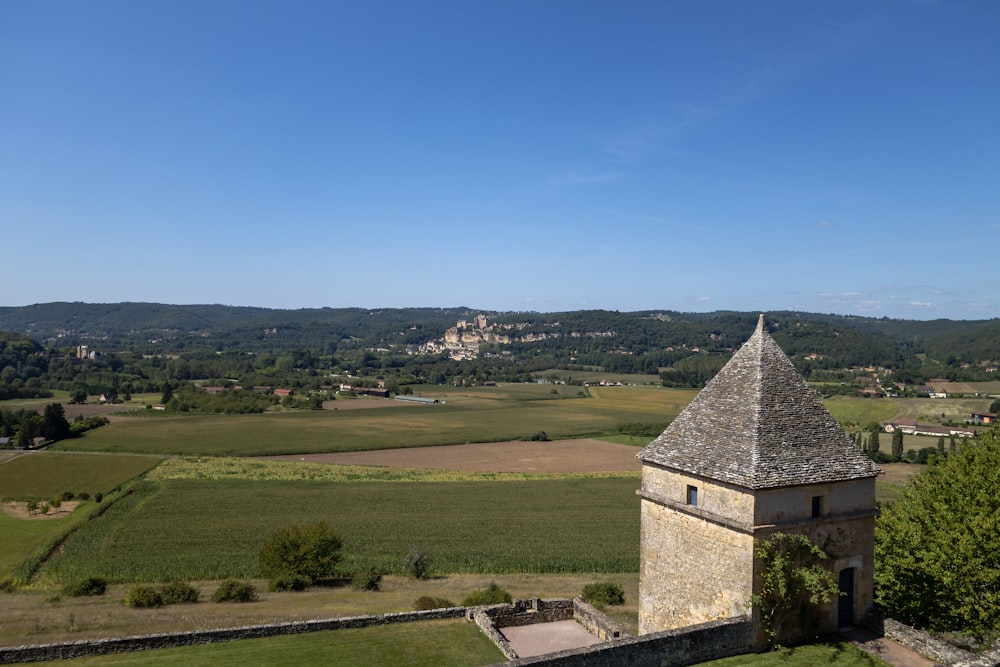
[638,315,881,637]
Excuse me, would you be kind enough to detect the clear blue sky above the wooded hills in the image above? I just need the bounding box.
[0,0,1000,319]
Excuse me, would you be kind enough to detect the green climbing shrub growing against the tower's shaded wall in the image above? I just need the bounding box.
[750,533,840,646]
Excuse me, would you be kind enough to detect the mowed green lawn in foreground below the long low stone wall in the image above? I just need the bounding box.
[26,618,505,667]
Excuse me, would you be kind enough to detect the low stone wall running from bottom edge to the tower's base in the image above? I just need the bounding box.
[493,617,753,667]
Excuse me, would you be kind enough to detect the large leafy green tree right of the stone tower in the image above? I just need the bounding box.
[875,426,1000,640]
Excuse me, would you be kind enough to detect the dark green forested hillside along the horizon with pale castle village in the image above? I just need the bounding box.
[0,303,1000,404]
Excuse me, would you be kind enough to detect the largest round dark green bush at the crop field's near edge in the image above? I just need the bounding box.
[260,521,343,583]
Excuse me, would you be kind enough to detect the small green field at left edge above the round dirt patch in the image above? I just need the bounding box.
[0,452,162,500]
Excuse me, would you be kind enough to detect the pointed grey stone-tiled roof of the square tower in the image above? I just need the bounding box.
[638,315,881,489]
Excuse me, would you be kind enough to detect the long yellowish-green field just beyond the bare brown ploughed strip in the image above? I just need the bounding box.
[50,387,696,456]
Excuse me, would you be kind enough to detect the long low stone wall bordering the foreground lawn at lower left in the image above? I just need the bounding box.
[0,607,466,664]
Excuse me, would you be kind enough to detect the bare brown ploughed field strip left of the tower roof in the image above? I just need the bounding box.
[268,439,642,473]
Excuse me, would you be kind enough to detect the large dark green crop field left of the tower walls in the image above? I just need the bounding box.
[44,477,639,581]
